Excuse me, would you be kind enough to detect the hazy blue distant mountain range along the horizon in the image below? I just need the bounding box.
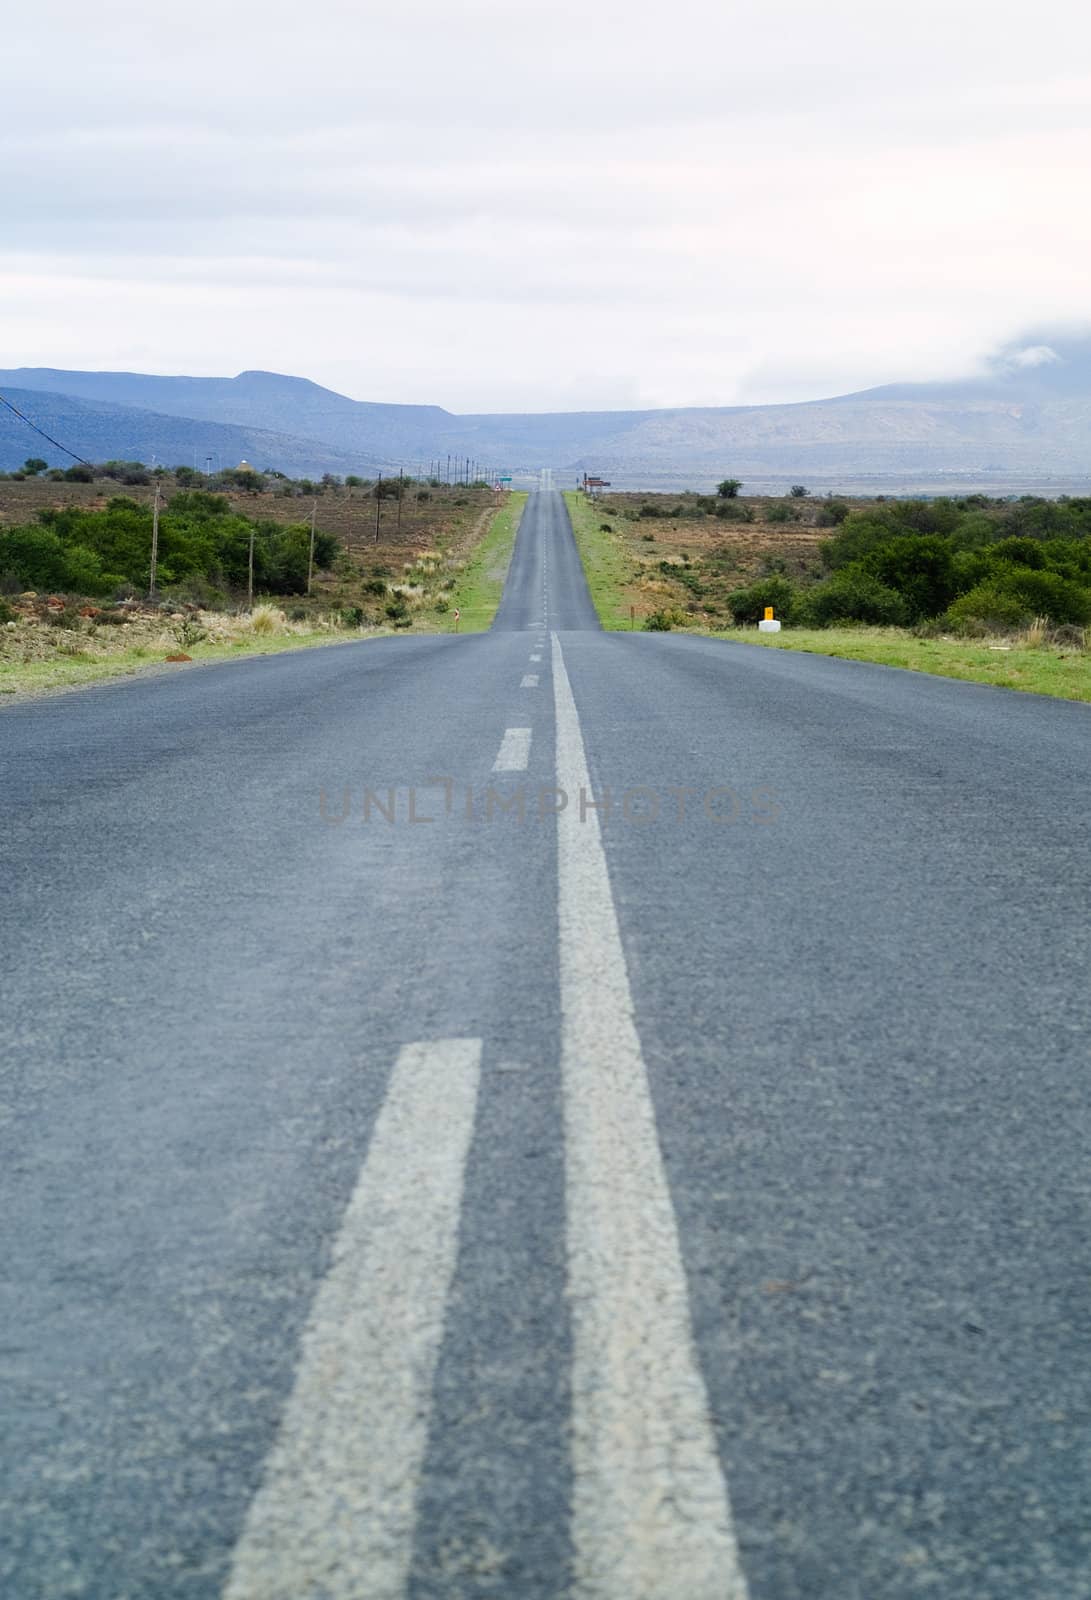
[0,338,1091,493]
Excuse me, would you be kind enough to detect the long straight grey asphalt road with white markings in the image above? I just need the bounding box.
[0,494,1091,1600]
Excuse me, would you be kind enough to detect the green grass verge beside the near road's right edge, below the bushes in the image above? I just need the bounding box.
[712,627,1091,701]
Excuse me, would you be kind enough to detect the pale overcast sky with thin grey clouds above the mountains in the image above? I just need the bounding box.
[0,0,1091,411]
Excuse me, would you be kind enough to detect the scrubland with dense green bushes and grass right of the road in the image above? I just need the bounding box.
[571,478,1091,699]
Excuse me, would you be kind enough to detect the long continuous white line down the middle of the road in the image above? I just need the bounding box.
[553,634,747,1600]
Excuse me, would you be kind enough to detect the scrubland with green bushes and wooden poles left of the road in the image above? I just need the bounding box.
[0,462,517,694]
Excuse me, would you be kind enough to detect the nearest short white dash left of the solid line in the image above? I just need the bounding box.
[224,1038,482,1600]
